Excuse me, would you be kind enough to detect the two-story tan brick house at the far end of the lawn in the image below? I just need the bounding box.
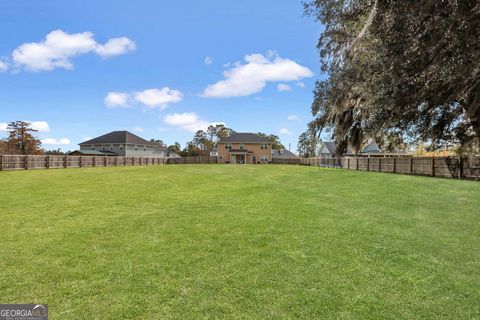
[217,133,272,164]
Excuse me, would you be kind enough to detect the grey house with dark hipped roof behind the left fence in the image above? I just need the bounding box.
[77,131,168,158]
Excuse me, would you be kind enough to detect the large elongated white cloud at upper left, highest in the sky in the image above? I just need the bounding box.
[12,30,135,71]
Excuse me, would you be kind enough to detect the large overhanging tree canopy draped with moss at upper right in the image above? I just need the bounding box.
[304,0,480,155]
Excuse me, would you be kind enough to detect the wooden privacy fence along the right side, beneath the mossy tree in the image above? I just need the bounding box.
[299,157,480,180]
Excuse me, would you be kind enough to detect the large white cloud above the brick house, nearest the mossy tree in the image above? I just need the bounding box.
[202,52,313,98]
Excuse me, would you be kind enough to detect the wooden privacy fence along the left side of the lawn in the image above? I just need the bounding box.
[0,155,168,170]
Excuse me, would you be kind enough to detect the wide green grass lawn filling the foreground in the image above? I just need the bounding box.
[0,165,480,319]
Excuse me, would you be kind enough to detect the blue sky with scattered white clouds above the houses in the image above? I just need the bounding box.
[0,0,321,150]
